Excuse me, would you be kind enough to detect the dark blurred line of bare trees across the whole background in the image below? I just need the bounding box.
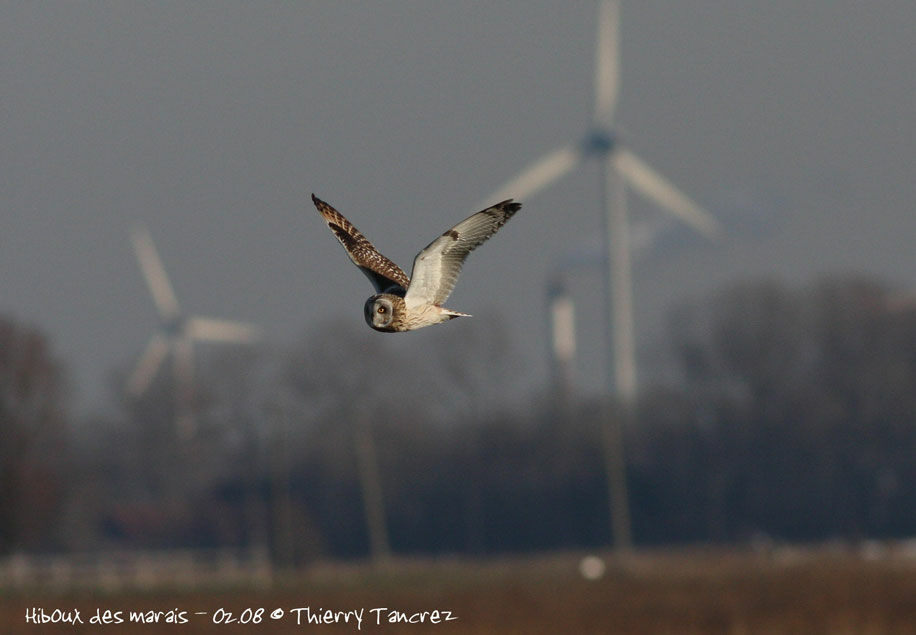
[0,276,916,564]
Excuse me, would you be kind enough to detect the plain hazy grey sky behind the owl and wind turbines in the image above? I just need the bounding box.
[0,0,916,411]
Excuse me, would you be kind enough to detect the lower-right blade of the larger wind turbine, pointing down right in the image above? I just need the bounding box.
[614,149,721,238]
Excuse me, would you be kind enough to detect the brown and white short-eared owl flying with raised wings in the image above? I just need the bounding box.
[312,194,521,333]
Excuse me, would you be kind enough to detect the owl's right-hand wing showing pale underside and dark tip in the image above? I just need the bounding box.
[404,199,521,307]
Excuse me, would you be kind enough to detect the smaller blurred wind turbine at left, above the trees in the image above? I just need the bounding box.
[127,225,260,434]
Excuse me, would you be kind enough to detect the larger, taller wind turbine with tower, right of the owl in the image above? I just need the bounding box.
[476,0,719,550]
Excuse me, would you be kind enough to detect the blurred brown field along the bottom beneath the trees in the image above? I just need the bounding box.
[0,548,916,635]
